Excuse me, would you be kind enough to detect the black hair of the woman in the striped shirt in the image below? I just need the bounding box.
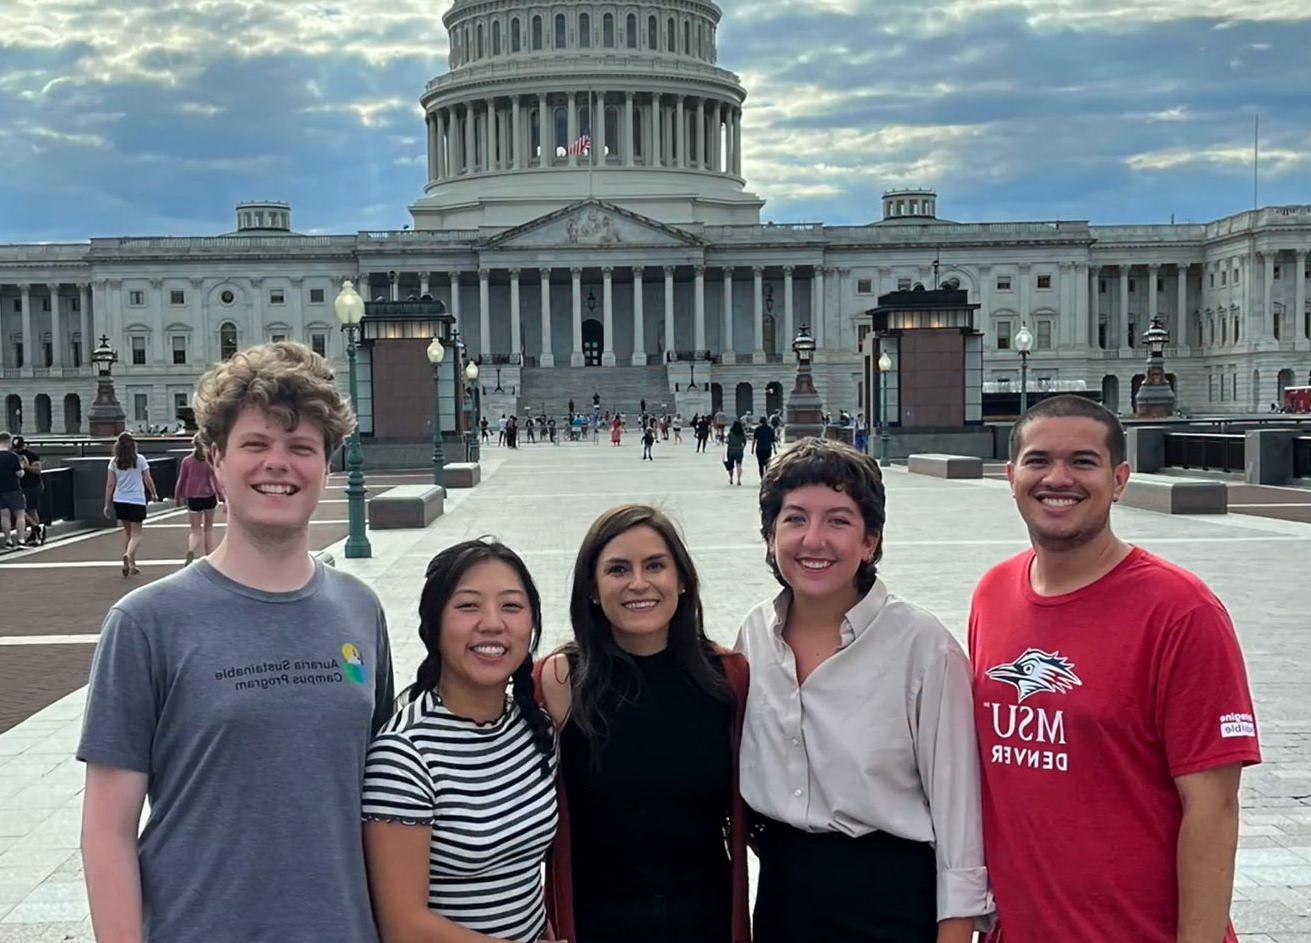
[401,536,555,776]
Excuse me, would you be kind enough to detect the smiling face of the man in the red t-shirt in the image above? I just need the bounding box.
[1006,416,1129,550]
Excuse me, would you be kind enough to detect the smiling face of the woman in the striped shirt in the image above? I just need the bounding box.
[438,560,532,691]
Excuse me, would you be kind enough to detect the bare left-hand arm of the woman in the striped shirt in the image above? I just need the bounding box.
[364,821,511,943]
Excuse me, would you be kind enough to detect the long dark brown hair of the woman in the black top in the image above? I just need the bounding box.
[564,504,733,762]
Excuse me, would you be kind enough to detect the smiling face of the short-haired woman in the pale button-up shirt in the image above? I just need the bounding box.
[768,484,880,605]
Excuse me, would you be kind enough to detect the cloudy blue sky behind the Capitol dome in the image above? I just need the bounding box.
[0,0,1311,243]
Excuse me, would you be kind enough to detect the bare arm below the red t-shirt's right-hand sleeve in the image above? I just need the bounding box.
[1175,763,1243,943]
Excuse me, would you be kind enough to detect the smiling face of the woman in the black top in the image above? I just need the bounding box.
[593,525,683,654]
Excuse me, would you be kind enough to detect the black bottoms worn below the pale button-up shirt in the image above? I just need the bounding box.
[753,820,937,943]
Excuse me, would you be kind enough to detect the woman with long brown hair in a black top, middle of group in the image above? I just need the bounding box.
[536,505,750,943]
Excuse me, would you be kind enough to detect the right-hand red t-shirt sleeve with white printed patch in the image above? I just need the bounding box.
[1155,602,1261,776]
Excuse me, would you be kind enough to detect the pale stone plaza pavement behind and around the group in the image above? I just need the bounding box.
[0,438,1311,943]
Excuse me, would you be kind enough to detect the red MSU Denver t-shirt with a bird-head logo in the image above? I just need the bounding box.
[969,548,1261,943]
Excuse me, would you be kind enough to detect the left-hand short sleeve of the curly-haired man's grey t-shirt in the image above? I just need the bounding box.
[77,607,159,774]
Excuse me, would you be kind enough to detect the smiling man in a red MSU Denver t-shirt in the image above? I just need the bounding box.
[969,396,1261,943]
